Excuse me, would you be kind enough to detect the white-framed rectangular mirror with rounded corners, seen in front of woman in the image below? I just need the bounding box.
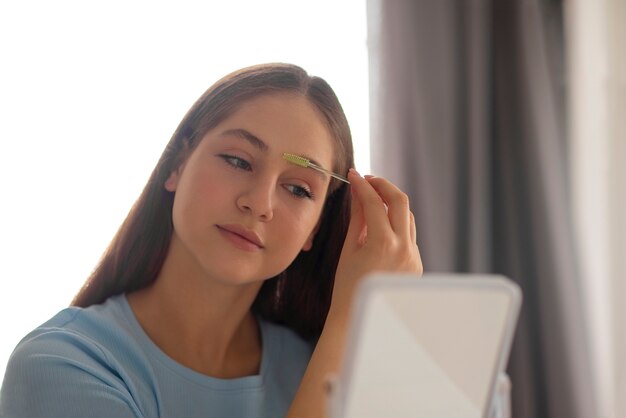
[329,274,521,418]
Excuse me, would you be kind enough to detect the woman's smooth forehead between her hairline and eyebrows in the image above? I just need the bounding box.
[212,93,335,167]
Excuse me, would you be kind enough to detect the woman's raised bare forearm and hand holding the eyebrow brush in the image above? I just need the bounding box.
[288,170,422,418]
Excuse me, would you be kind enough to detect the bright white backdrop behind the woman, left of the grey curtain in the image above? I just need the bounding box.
[0,0,369,376]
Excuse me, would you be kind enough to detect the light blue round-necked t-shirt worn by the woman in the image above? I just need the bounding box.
[0,295,313,418]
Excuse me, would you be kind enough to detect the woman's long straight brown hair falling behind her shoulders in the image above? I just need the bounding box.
[72,64,354,338]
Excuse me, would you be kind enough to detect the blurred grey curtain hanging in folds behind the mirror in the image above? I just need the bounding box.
[368,0,596,418]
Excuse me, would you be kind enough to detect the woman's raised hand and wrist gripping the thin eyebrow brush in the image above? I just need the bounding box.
[329,169,423,318]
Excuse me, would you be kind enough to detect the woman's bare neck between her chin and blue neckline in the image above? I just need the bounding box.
[128,242,262,378]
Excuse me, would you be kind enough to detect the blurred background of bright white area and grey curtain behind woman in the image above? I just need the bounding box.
[0,0,626,418]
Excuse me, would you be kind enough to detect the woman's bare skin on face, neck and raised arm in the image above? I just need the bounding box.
[128,93,422,418]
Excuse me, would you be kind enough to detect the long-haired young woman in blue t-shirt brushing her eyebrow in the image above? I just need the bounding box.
[0,64,422,418]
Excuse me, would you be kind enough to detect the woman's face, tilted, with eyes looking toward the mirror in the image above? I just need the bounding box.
[165,93,334,284]
